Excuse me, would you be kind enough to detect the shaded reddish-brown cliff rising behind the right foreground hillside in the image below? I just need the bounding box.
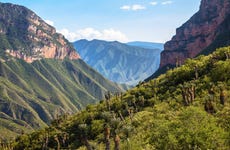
[160,0,230,67]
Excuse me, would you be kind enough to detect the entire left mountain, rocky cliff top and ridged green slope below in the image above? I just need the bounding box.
[0,3,122,139]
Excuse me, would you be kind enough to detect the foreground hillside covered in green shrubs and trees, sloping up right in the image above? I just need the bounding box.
[6,47,230,150]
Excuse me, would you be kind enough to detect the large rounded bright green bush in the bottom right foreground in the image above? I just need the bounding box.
[150,106,227,150]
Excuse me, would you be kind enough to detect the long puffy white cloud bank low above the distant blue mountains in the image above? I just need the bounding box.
[58,28,128,42]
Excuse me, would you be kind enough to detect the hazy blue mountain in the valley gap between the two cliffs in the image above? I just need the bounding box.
[74,40,161,84]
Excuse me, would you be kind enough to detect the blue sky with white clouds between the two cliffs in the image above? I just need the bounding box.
[0,0,201,43]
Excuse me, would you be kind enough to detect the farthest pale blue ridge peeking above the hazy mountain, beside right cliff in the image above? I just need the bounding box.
[126,41,164,50]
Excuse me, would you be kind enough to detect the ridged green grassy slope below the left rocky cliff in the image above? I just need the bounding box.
[0,59,121,139]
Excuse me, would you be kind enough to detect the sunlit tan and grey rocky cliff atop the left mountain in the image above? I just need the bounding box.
[0,3,80,62]
